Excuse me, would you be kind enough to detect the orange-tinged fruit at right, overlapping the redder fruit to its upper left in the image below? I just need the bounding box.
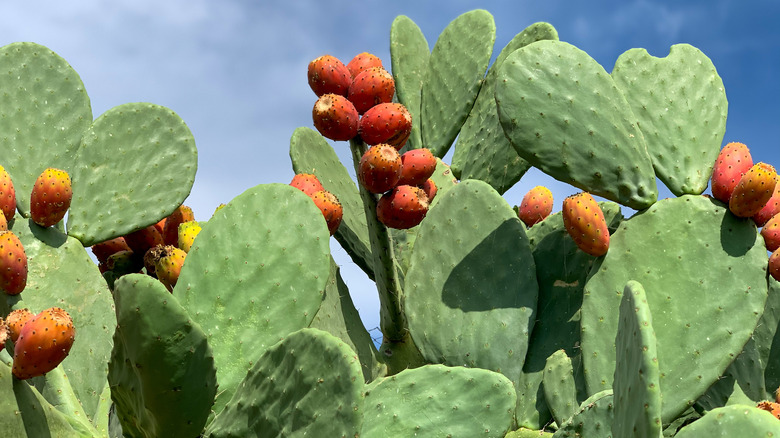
[729,163,777,217]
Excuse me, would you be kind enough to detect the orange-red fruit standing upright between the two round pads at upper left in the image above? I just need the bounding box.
[30,167,73,227]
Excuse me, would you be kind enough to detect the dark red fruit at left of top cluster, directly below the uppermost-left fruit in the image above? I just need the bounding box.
[312,94,360,141]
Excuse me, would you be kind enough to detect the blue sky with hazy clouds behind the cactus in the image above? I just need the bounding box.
[0,0,780,334]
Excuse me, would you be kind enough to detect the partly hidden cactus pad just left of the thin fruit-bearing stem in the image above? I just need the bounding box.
[290,128,374,280]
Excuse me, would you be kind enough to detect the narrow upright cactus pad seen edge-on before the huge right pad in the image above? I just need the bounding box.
[612,281,663,438]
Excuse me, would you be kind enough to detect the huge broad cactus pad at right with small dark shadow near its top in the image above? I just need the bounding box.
[581,195,767,423]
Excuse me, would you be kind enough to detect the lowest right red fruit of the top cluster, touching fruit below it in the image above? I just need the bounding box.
[359,103,412,150]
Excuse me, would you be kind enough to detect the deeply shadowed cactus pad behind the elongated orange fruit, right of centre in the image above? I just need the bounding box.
[516,202,623,429]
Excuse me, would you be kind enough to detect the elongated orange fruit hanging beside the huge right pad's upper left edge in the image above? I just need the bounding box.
[562,192,609,257]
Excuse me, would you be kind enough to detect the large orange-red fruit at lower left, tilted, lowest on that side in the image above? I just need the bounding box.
[12,307,76,380]
